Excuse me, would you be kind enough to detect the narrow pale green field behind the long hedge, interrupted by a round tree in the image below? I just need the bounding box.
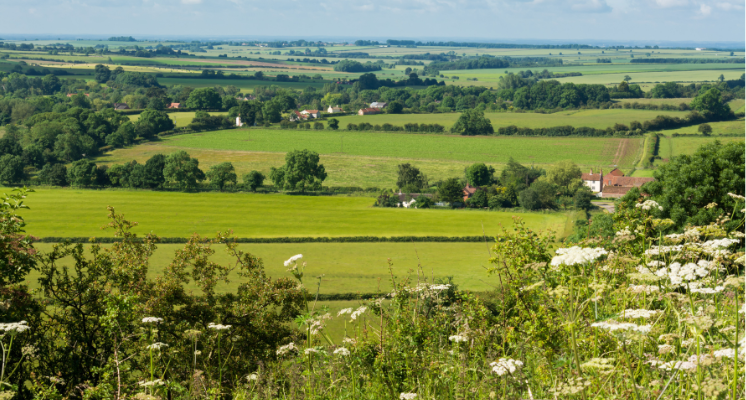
[324,109,687,130]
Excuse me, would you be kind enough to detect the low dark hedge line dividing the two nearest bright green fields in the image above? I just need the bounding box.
[34,236,495,244]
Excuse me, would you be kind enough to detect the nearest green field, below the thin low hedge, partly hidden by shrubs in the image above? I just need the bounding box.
[29,241,506,294]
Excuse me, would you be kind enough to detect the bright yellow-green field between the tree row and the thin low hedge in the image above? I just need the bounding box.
[13,188,567,237]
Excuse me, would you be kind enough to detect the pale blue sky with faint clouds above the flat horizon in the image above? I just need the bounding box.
[0,0,745,43]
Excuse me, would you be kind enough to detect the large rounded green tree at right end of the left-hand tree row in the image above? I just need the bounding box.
[269,150,326,193]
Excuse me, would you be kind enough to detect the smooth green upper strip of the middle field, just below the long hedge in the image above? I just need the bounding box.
[155,129,640,166]
